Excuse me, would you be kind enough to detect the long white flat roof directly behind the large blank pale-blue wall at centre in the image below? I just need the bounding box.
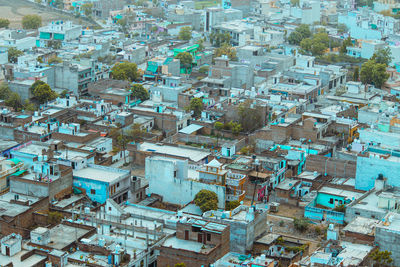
[139,142,210,162]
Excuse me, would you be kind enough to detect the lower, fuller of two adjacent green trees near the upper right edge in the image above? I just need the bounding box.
[360,59,389,88]
